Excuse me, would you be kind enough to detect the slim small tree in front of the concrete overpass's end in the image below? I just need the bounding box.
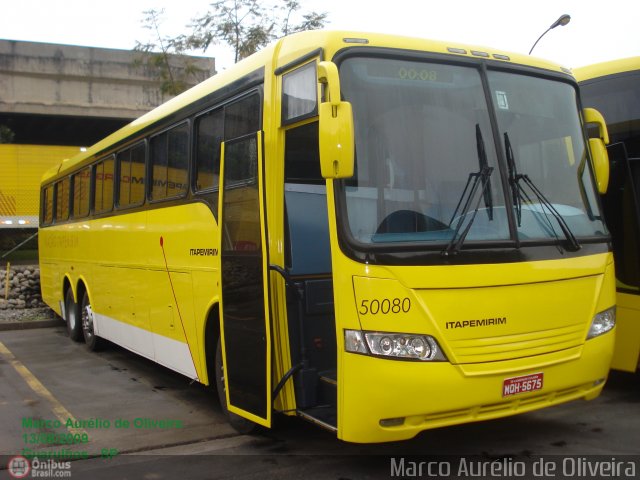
[134,9,202,95]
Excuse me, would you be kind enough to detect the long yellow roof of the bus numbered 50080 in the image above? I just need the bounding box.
[42,30,571,183]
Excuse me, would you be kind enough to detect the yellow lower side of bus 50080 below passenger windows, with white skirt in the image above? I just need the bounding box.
[39,203,219,384]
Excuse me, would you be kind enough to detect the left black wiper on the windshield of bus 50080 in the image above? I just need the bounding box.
[440,165,493,257]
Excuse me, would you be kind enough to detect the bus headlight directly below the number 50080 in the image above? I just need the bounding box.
[344,330,447,362]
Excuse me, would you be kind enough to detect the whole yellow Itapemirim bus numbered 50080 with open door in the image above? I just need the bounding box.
[39,32,615,442]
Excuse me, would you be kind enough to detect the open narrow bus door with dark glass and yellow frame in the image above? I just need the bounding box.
[218,132,271,426]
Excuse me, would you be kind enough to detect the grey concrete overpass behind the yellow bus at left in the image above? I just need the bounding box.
[0,40,215,145]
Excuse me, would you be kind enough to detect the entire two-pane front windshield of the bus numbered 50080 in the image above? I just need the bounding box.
[339,57,606,248]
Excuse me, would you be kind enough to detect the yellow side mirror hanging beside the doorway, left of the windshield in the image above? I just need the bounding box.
[318,62,355,178]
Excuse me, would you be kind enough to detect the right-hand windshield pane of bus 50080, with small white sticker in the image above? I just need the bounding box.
[489,71,606,240]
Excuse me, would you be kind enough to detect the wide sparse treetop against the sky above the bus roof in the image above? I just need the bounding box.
[182,0,328,62]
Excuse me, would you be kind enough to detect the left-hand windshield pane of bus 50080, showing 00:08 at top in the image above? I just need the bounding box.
[340,58,509,244]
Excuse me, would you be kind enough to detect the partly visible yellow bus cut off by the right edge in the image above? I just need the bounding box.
[574,57,640,372]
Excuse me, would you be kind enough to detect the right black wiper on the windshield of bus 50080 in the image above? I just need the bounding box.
[504,132,581,252]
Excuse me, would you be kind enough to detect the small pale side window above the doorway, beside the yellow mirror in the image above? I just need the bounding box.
[282,62,318,125]
